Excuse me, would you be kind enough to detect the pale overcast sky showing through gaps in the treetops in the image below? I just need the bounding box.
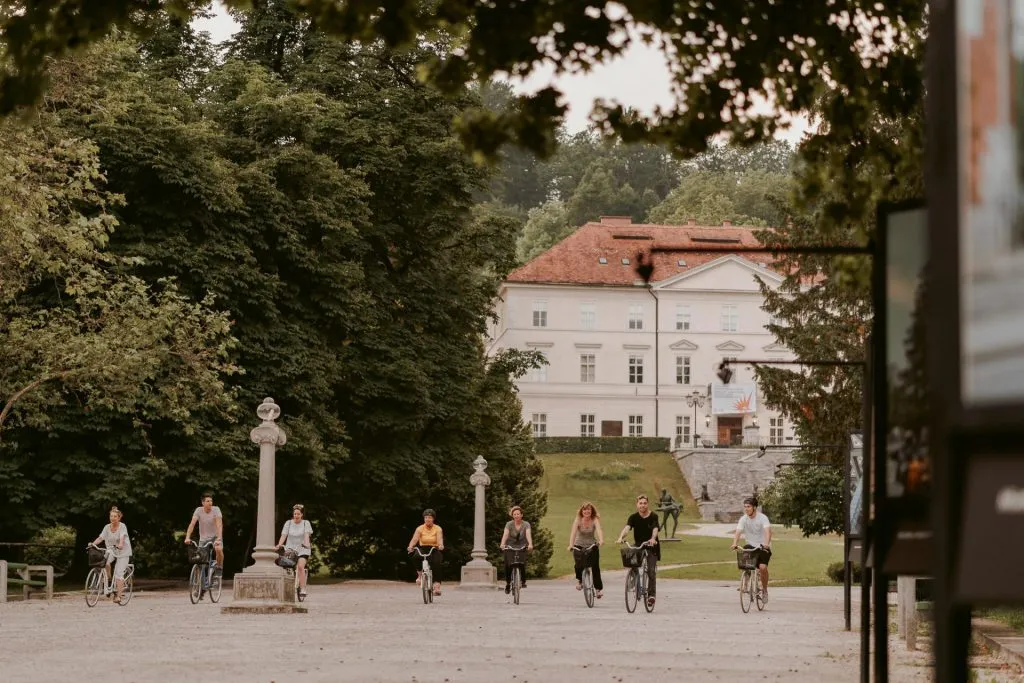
[195,2,808,143]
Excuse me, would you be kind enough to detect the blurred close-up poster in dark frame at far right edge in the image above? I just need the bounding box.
[955,0,1024,408]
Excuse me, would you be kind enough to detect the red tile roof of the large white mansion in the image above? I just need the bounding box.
[507,222,773,286]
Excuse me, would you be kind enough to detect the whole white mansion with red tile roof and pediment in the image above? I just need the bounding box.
[488,216,795,445]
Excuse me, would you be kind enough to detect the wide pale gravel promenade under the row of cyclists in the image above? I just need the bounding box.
[0,572,1015,683]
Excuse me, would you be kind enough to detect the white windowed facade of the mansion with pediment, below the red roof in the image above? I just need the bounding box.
[488,255,796,445]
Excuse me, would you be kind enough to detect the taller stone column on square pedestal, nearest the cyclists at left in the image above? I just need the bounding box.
[221,398,306,613]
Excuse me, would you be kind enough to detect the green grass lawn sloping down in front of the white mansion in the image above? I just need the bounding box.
[540,453,843,585]
